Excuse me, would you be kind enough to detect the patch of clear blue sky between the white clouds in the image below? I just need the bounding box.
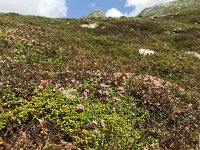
[67,0,133,18]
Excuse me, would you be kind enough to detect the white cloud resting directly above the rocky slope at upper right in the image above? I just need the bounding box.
[125,0,174,16]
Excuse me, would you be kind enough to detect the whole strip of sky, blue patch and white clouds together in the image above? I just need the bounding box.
[0,0,173,18]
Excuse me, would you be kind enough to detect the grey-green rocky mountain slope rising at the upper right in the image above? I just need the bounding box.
[139,0,200,17]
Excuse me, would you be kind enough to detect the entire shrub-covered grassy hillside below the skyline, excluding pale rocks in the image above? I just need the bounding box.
[0,10,200,150]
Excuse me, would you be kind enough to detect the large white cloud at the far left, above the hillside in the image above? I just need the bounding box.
[0,0,67,18]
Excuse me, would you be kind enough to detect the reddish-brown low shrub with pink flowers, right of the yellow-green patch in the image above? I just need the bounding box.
[128,75,200,149]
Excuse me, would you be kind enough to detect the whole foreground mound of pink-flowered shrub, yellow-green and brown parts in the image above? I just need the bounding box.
[0,71,199,149]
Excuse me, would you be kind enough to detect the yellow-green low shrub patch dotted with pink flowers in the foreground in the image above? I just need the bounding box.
[0,78,158,149]
